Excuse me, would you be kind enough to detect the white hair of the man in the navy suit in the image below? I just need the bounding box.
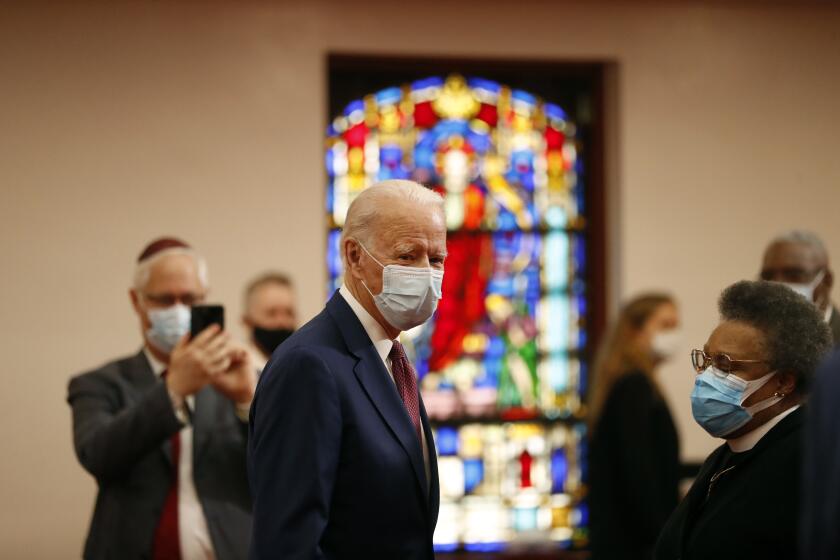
[340,179,443,269]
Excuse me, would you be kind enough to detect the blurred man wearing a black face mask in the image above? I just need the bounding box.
[242,272,297,369]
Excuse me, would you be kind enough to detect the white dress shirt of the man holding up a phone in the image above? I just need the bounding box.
[143,348,216,560]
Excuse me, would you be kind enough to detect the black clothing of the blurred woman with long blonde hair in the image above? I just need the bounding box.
[589,372,679,560]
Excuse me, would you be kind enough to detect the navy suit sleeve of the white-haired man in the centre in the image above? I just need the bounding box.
[249,347,342,560]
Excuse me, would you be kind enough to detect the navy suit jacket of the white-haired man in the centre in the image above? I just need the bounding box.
[248,292,439,560]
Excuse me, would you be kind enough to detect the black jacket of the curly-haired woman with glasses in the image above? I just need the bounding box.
[654,408,805,560]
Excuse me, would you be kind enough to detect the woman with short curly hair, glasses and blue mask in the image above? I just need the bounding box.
[654,281,831,560]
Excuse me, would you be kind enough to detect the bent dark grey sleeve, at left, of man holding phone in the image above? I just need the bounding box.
[67,372,181,480]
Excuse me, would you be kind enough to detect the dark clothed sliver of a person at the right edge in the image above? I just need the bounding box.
[799,351,840,560]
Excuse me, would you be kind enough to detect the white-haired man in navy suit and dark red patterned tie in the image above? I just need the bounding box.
[248,181,446,560]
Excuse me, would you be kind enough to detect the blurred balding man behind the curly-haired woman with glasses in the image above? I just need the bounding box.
[761,230,840,346]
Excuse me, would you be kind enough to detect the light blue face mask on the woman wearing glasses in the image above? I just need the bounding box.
[691,366,783,437]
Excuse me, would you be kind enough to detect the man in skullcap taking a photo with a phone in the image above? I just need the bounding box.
[67,238,256,560]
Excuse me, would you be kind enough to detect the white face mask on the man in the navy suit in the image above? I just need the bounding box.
[357,240,443,331]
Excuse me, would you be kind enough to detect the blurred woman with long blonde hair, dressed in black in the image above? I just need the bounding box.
[589,294,679,560]
